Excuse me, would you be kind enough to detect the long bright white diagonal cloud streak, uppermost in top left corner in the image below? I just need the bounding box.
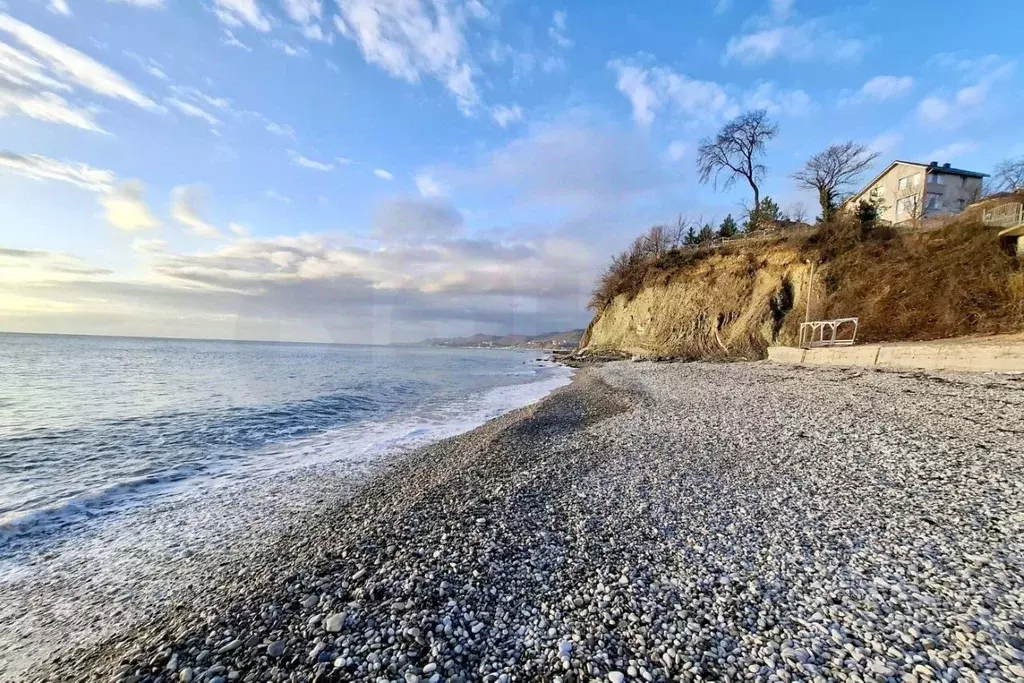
[0,14,161,112]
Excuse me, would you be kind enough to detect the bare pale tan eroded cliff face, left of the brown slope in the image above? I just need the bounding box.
[579,245,810,358]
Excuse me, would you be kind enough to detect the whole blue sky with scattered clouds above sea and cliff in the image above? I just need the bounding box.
[0,0,1024,343]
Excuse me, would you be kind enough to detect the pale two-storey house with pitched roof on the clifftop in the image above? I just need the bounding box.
[843,160,988,223]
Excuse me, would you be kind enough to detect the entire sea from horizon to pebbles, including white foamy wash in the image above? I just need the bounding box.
[0,334,571,680]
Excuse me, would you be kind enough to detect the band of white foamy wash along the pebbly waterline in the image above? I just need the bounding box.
[0,352,572,679]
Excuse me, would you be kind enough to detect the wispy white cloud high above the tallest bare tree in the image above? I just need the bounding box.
[723,19,866,65]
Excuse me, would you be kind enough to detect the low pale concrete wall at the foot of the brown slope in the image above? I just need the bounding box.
[768,342,1024,373]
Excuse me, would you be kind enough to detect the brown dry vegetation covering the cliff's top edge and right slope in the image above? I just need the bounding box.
[590,206,1024,344]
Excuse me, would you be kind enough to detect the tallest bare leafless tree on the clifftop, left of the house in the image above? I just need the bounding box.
[697,110,778,231]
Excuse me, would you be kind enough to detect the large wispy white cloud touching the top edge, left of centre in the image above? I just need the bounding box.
[335,0,480,115]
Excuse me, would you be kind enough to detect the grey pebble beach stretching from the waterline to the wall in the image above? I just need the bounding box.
[26,362,1024,683]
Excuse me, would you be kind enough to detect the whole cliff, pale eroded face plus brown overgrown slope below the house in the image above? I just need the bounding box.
[578,215,1024,359]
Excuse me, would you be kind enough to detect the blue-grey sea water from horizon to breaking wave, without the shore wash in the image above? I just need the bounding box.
[0,334,568,557]
